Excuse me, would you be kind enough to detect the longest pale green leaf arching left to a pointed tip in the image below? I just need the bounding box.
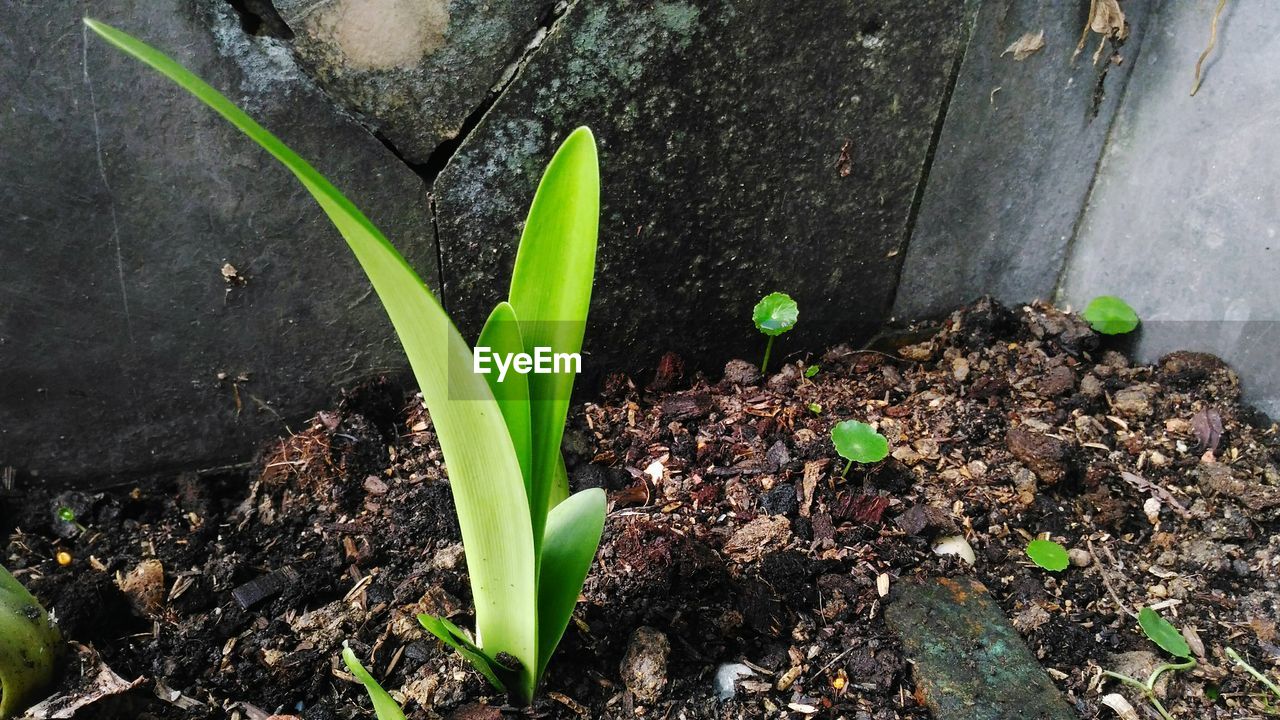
[84,18,536,685]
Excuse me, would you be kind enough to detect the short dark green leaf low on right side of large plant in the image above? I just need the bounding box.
[535,488,605,678]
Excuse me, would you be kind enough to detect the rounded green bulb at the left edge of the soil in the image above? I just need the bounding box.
[0,568,63,719]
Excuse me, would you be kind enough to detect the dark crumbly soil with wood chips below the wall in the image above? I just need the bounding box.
[6,295,1280,720]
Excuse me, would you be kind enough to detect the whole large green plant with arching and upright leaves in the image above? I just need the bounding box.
[84,19,606,705]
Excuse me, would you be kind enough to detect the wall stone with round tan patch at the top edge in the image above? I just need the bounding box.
[275,0,552,163]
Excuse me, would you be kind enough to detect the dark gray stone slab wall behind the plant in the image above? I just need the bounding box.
[12,0,1280,482]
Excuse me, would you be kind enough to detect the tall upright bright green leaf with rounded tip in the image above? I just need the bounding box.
[509,127,600,542]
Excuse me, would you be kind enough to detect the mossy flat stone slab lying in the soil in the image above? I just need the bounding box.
[884,578,1078,720]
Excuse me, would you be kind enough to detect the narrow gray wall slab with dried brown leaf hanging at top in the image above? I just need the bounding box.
[893,0,1157,319]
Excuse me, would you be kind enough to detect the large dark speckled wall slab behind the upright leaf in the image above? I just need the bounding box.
[434,0,965,379]
